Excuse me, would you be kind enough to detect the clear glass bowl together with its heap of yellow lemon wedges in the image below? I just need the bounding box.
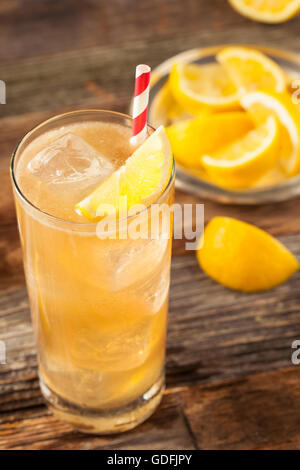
[149,45,300,204]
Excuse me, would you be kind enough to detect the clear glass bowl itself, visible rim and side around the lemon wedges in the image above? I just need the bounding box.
[149,45,300,204]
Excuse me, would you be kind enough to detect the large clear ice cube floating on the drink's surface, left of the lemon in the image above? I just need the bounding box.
[27,132,114,184]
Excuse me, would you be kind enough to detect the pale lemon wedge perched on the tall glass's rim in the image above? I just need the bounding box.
[76,126,172,220]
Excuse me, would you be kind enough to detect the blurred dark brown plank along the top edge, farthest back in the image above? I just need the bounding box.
[0,0,255,60]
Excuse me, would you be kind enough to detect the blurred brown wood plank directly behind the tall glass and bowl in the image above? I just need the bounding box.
[0,12,300,116]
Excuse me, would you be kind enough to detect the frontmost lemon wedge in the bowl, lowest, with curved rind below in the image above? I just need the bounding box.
[201,117,279,189]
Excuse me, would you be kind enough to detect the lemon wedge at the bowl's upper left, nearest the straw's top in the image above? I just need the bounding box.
[169,64,240,115]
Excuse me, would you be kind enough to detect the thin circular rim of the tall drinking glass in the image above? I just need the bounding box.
[10,108,175,228]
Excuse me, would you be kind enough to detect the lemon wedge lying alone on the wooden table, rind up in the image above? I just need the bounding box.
[197,217,299,292]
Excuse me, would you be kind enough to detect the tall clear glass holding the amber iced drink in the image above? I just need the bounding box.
[11,110,174,433]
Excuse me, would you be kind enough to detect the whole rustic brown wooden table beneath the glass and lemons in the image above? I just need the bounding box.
[0,0,300,449]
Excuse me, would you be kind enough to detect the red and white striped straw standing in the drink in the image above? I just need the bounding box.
[131,64,151,145]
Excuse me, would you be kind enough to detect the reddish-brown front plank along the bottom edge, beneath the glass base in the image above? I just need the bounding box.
[0,367,300,450]
